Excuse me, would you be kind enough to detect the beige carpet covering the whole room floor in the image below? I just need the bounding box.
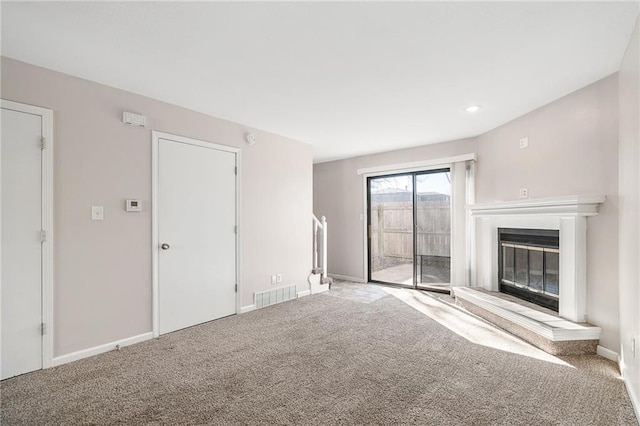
[0,283,637,425]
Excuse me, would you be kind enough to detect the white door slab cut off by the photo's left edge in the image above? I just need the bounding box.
[0,108,43,379]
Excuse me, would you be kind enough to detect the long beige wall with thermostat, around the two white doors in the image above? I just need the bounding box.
[1,58,312,356]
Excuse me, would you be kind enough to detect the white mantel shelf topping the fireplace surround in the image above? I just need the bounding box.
[466,195,605,217]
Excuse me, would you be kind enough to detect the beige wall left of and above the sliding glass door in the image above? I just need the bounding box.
[313,139,476,280]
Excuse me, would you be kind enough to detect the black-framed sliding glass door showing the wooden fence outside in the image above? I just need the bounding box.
[367,169,451,290]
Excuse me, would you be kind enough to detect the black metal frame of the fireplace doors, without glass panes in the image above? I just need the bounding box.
[498,228,560,312]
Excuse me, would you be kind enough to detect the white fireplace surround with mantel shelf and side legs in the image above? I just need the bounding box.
[467,195,605,322]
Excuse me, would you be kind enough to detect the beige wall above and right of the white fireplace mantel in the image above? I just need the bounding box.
[476,74,619,351]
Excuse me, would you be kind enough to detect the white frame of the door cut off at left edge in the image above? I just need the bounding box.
[0,99,54,368]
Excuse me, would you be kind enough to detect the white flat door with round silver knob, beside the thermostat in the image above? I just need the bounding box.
[156,138,237,334]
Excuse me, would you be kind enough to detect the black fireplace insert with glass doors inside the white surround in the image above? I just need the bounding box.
[498,228,560,312]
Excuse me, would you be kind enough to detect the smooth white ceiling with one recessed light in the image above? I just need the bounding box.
[1,1,638,162]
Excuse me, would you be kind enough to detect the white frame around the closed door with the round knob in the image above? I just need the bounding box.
[151,130,242,337]
